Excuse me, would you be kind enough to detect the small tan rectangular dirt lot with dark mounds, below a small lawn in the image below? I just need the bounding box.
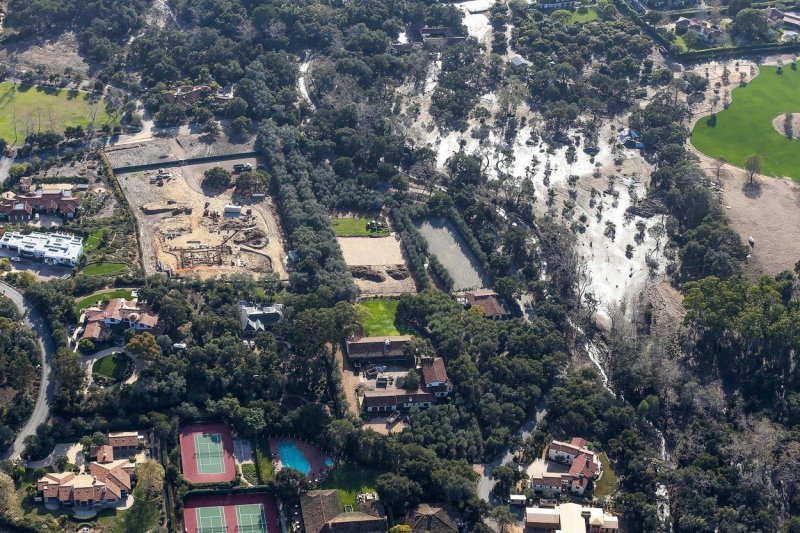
[337,235,417,296]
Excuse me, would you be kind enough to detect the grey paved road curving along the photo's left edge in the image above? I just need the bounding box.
[0,282,56,459]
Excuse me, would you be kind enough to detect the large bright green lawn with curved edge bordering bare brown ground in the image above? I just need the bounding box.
[691,65,800,180]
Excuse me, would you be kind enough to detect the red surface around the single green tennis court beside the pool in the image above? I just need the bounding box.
[180,422,236,483]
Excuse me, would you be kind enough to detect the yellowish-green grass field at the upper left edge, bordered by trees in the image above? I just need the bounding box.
[0,81,113,145]
